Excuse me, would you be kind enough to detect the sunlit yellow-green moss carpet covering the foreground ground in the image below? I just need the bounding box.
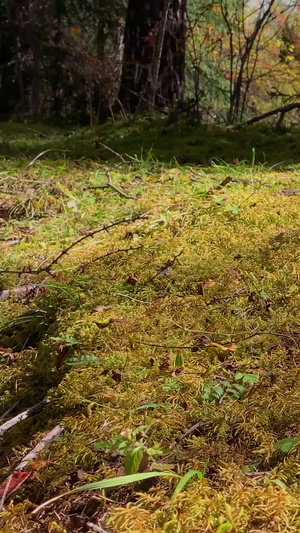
[0,160,300,533]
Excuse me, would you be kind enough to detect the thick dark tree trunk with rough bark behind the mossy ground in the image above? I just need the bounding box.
[119,0,186,112]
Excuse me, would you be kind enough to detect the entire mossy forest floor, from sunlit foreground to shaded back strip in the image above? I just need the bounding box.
[0,124,300,533]
